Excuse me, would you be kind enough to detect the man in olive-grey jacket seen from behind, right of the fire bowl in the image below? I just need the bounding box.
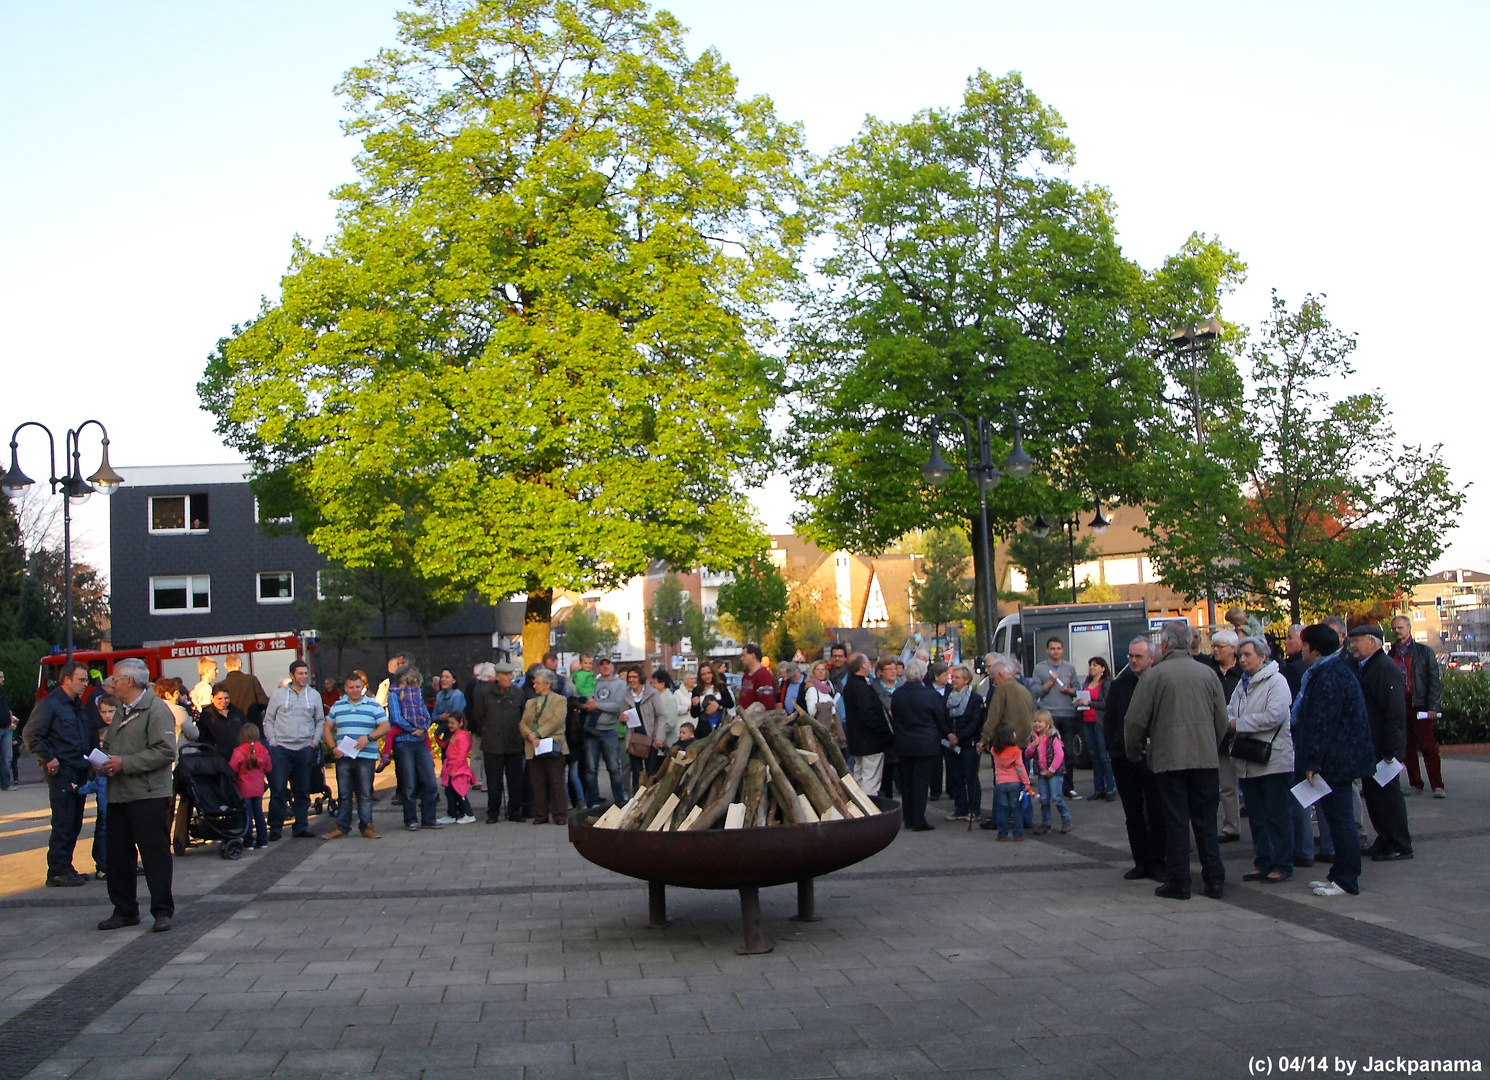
[1123,620,1226,900]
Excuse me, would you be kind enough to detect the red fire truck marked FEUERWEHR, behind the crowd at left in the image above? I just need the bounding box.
[36,630,316,700]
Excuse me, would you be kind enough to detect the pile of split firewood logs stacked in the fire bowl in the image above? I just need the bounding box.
[595,705,879,833]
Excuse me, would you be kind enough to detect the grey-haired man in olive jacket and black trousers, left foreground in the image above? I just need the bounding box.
[94,658,176,933]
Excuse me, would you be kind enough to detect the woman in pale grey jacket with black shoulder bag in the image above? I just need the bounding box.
[1226,638,1293,885]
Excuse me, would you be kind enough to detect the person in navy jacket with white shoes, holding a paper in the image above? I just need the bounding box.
[1293,623,1372,897]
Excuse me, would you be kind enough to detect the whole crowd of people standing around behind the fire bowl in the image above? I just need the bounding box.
[17,611,1447,930]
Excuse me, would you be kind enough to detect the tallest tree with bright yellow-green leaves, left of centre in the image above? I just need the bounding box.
[200,0,805,661]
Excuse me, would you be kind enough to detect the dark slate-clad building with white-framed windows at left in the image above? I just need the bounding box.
[109,465,522,675]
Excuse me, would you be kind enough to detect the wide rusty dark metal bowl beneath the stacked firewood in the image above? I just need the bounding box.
[569,797,900,889]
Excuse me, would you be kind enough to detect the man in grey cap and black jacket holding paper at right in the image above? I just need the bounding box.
[1337,623,1413,863]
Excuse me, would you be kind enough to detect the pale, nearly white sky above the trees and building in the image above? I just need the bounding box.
[0,0,1490,571]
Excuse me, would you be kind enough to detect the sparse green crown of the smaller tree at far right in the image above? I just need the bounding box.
[1147,293,1465,623]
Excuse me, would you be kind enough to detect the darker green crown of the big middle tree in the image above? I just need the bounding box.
[785,72,1243,551]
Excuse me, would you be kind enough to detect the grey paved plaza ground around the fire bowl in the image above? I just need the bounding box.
[0,757,1490,1080]
